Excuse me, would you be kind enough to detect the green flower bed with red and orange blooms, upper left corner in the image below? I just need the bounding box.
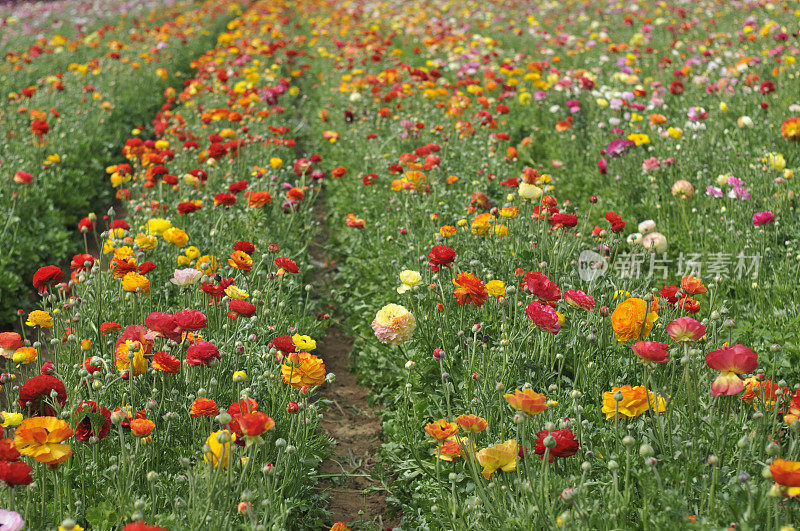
[0,2,238,324]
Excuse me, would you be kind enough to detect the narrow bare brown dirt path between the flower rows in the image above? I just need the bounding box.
[309,197,395,529]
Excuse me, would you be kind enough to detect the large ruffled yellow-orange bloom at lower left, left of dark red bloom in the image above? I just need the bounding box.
[14,417,73,466]
